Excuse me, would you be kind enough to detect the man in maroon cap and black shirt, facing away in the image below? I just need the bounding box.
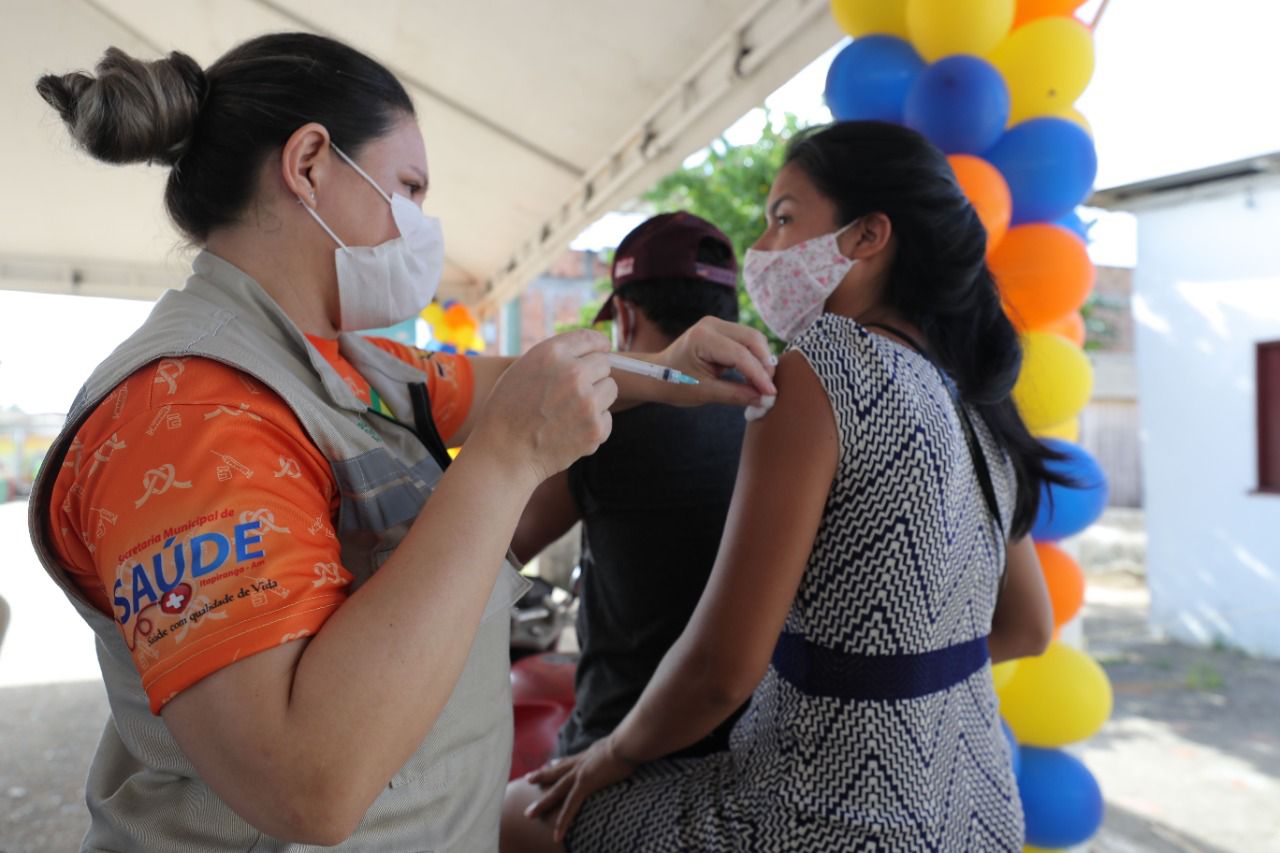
[512,213,745,756]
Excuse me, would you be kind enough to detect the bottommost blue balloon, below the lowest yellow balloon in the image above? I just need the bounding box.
[1018,747,1102,849]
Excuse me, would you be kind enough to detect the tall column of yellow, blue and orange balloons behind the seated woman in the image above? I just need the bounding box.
[826,0,1111,848]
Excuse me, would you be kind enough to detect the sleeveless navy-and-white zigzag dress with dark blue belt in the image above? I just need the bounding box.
[567,314,1023,853]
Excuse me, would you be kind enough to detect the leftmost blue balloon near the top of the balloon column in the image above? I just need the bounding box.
[823,36,924,124]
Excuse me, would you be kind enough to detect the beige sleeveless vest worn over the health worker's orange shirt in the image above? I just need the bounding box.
[31,252,527,853]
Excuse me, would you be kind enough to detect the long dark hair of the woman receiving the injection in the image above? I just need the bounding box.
[786,122,1065,538]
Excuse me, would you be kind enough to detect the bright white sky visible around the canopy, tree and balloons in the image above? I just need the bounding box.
[0,0,1280,411]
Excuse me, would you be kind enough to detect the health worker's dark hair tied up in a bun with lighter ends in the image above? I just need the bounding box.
[36,33,413,245]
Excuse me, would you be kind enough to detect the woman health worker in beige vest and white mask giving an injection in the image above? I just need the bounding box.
[31,33,776,852]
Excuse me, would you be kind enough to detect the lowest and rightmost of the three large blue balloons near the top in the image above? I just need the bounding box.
[982,118,1098,225]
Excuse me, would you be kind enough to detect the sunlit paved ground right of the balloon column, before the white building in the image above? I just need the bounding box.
[1078,575,1280,853]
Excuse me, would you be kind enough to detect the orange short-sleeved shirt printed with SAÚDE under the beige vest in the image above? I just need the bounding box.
[50,338,474,713]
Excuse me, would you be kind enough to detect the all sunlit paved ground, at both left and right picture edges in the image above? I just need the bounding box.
[0,503,1280,853]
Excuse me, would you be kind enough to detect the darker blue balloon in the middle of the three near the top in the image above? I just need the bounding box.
[902,54,1009,154]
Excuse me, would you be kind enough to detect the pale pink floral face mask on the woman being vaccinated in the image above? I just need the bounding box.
[742,223,858,341]
